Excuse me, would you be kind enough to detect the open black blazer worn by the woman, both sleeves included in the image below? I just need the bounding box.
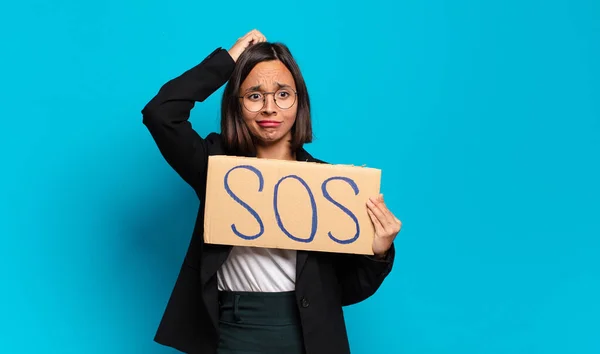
[142,48,395,354]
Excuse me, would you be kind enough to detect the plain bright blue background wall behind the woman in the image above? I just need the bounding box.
[0,0,600,354]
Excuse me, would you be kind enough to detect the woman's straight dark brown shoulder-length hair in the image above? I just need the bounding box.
[221,42,313,156]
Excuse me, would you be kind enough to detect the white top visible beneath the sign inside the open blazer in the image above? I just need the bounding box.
[217,246,296,292]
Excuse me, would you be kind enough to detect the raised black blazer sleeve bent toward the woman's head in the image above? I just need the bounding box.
[142,48,235,192]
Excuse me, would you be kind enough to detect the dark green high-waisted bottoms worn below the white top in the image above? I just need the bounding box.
[218,292,304,354]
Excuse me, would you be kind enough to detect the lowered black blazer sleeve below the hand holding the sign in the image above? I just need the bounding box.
[336,244,396,306]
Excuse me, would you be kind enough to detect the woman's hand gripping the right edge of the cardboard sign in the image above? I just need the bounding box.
[367,194,402,257]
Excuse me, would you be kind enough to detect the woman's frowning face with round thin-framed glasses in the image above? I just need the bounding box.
[239,60,298,145]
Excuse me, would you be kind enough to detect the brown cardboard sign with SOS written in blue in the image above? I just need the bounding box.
[204,156,381,255]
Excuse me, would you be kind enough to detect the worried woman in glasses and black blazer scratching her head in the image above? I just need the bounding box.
[142,30,401,354]
